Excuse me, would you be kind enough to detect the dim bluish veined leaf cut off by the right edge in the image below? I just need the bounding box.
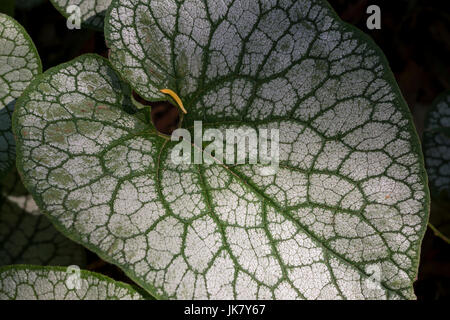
[423,91,450,195]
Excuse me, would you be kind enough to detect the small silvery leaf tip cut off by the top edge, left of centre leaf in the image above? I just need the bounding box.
[50,0,112,31]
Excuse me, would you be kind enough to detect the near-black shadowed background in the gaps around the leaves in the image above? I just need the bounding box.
[0,0,450,300]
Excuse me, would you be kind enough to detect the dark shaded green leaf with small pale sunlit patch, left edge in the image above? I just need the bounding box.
[0,170,86,266]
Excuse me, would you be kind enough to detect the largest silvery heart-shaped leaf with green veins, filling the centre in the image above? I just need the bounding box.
[14,0,429,299]
